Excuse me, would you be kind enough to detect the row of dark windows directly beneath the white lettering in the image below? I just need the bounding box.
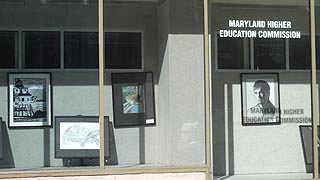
[213,35,312,70]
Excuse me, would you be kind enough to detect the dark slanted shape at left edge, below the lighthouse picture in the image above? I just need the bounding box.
[0,118,15,168]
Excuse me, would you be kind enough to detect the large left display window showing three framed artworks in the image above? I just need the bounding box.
[0,0,209,177]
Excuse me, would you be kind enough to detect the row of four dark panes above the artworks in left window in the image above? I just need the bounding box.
[0,31,143,69]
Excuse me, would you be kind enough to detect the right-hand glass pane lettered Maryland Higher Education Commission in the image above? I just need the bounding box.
[210,0,313,180]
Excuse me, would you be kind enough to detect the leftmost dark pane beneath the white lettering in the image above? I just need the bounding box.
[218,38,249,69]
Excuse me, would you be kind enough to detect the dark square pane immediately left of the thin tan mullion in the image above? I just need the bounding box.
[64,32,99,68]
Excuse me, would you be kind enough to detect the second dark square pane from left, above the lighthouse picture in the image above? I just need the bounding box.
[24,31,60,68]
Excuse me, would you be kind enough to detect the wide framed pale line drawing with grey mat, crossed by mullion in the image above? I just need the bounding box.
[55,116,110,158]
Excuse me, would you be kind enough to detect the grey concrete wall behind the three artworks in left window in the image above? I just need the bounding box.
[0,0,204,169]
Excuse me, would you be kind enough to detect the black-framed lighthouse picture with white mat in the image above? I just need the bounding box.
[8,73,52,128]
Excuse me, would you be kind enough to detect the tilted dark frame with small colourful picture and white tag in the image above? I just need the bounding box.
[111,72,156,127]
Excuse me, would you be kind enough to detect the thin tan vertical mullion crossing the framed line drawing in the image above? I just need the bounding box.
[98,0,104,169]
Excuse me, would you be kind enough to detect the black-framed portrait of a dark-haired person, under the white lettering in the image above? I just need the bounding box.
[241,73,281,125]
